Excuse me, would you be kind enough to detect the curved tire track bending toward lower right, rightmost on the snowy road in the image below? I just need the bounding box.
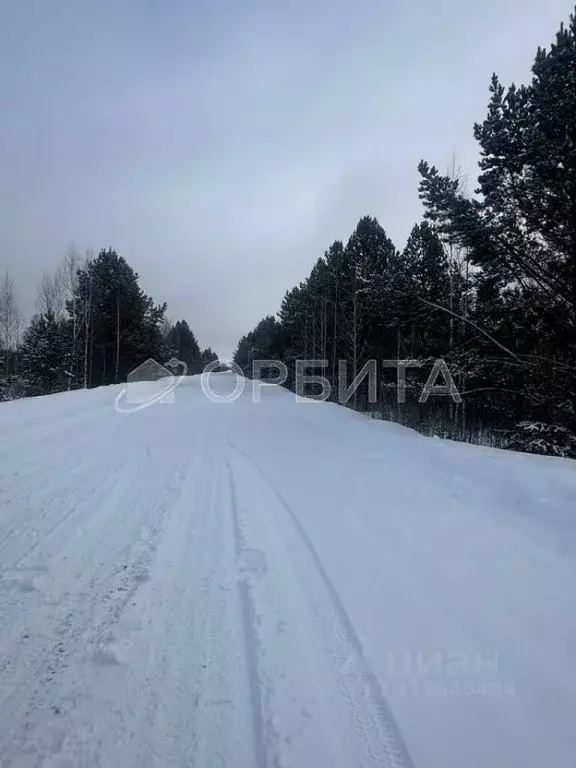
[230,444,414,768]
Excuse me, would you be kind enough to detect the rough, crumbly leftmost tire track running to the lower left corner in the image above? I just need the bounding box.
[0,456,190,764]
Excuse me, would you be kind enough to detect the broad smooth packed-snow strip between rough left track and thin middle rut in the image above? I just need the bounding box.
[65,451,257,768]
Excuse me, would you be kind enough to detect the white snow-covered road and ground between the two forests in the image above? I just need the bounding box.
[0,374,576,768]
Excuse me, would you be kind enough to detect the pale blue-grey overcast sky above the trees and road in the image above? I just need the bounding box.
[0,0,572,358]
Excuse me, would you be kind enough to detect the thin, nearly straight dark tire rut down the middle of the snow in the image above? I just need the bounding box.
[226,462,268,768]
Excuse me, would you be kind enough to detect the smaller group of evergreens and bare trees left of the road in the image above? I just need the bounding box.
[0,247,218,400]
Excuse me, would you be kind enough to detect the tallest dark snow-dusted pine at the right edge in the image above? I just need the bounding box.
[419,7,576,456]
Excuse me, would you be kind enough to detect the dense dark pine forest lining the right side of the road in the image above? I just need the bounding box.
[235,15,576,457]
